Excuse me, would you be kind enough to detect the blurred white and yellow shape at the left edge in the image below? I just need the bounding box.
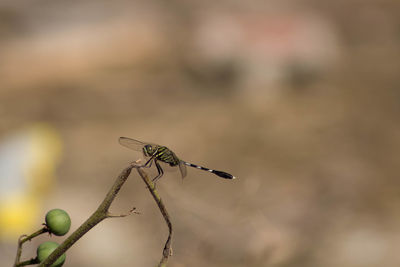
[0,124,61,242]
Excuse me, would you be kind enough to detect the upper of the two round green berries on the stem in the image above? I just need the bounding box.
[46,209,71,236]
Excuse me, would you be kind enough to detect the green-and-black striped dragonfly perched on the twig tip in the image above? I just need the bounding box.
[119,137,236,182]
